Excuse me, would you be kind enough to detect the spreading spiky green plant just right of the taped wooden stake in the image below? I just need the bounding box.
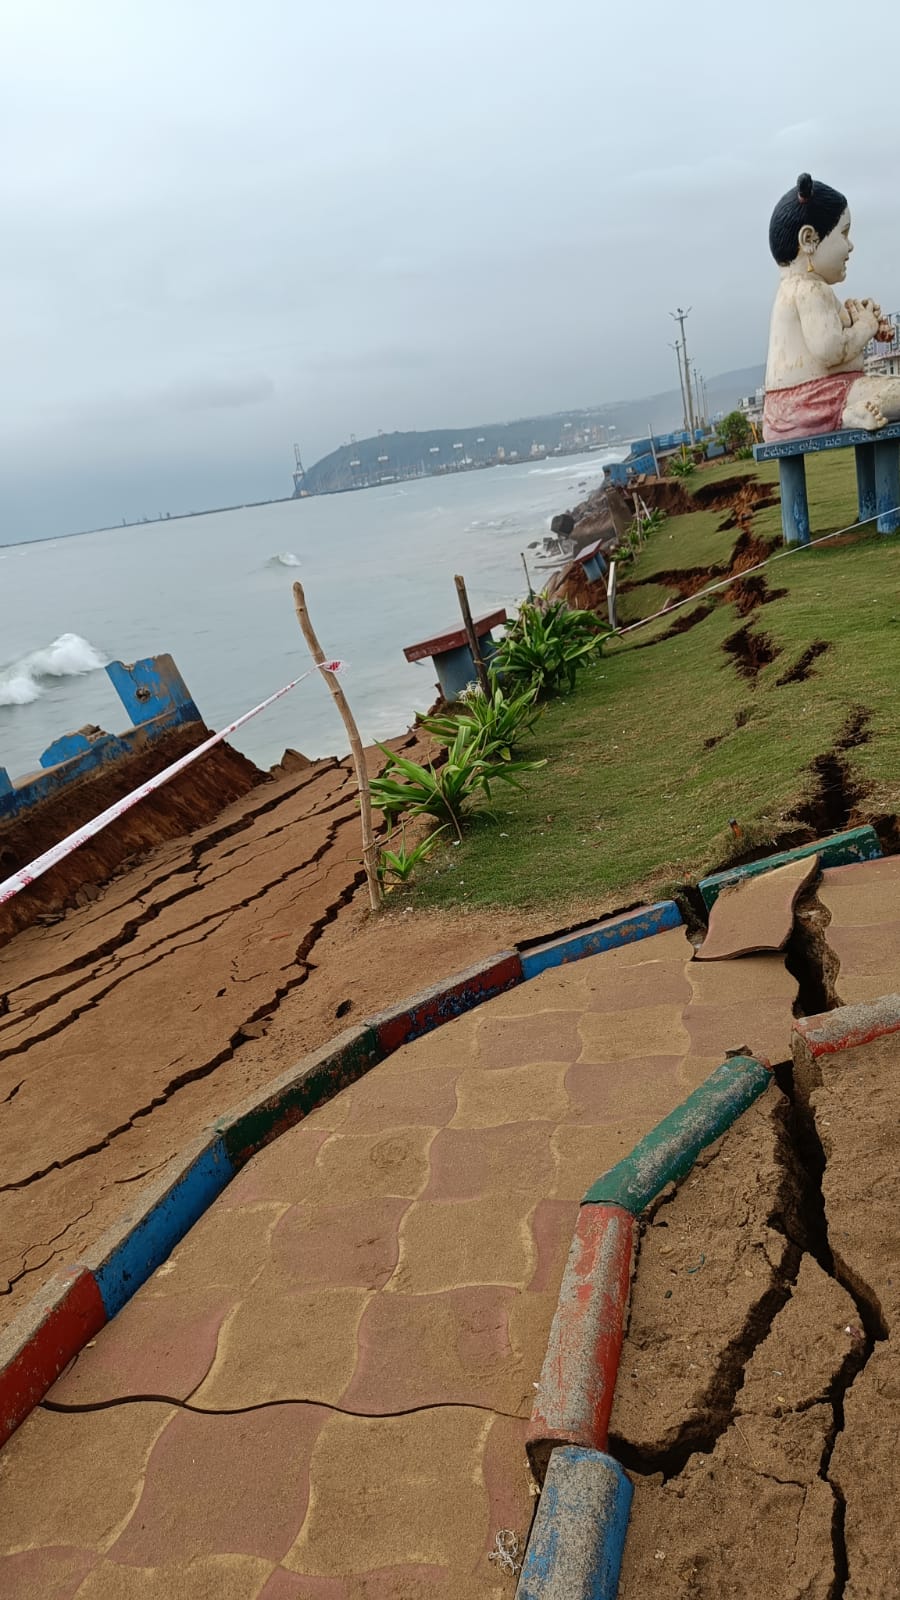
[368,723,544,838]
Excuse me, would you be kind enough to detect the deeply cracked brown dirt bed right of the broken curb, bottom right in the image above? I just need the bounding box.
[610,1038,900,1600]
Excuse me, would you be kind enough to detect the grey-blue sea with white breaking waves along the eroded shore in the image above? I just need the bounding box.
[0,451,621,778]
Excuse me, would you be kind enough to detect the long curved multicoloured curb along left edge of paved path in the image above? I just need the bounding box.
[0,902,666,1446]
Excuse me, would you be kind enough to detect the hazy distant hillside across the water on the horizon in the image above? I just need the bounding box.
[303,366,764,494]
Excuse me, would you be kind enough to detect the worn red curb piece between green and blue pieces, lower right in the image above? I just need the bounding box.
[525,1205,634,1482]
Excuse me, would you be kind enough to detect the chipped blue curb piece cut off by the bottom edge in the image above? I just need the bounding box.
[516,1445,634,1600]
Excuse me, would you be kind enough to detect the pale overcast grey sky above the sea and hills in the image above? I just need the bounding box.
[0,0,900,544]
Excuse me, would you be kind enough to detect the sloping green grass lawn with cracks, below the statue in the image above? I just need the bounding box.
[405,451,900,907]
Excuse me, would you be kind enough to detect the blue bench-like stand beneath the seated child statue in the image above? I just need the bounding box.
[753,422,900,544]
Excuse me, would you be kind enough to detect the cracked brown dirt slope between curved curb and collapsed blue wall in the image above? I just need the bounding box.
[0,738,589,1325]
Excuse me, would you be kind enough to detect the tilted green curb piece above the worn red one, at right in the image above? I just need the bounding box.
[581,1056,772,1214]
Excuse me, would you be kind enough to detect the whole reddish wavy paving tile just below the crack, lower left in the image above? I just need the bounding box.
[107,1405,330,1566]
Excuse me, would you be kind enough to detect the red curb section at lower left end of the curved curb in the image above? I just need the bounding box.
[0,1267,107,1445]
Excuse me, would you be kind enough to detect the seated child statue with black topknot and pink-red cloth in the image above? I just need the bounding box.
[762,173,900,442]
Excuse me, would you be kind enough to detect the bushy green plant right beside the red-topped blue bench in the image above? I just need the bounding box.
[490,600,610,694]
